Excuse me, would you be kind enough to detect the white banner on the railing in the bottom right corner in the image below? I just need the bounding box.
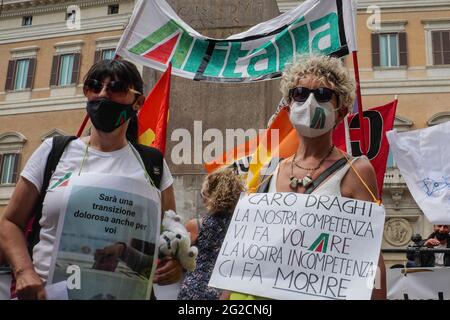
[386,268,450,300]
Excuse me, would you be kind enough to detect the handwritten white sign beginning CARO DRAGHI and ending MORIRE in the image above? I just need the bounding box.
[209,193,384,300]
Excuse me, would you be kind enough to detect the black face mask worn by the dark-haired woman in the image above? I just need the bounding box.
[86,98,137,132]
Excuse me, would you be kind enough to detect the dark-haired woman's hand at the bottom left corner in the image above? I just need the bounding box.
[16,269,46,300]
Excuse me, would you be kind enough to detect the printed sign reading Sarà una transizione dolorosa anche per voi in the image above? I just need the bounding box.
[49,173,161,300]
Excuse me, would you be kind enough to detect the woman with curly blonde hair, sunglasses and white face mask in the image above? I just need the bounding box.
[258,56,386,298]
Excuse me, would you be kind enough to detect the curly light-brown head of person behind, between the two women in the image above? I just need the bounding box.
[201,169,245,214]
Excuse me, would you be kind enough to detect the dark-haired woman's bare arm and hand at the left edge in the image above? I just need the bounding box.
[0,177,45,299]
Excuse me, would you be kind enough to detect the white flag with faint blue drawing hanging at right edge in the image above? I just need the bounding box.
[386,121,450,224]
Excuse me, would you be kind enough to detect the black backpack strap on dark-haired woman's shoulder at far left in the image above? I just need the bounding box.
[26,136,77,257]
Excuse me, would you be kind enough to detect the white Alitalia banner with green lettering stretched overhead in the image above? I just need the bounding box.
[117,0,356,82]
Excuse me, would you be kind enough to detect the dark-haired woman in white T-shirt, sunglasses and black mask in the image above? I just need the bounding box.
[0,60,181,299]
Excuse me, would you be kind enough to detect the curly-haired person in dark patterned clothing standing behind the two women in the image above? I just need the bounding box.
[178,169,245,300]
